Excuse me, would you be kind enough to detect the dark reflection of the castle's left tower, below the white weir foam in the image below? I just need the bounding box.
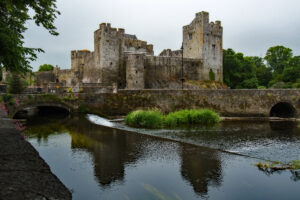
[68,118,141,185]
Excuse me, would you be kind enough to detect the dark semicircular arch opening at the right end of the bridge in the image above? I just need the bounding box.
[270,102,297,118]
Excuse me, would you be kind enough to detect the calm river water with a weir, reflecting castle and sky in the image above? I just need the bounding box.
[26,115,300,200]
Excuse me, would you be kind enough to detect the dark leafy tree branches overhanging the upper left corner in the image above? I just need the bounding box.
[0,0,60,73]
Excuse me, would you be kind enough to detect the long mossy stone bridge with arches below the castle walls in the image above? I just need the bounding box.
[5,89,300,118]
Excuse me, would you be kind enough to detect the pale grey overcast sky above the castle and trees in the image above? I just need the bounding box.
[25,0,300,70]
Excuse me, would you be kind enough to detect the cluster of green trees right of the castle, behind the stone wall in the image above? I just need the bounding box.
[223,46,300,88]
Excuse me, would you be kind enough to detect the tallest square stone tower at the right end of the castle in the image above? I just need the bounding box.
[183,12,223,82]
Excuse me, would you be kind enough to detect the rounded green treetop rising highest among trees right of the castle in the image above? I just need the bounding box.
[265,46,293,73]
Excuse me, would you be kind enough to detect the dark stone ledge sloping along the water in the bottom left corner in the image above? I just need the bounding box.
[0,106,72,200]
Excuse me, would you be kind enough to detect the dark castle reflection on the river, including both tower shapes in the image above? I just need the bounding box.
[26,117,226,196]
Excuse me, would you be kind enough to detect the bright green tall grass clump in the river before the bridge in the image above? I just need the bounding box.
[125,109,220,128]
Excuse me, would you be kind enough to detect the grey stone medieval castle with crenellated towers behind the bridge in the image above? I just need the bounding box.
[32,12,223,89]
